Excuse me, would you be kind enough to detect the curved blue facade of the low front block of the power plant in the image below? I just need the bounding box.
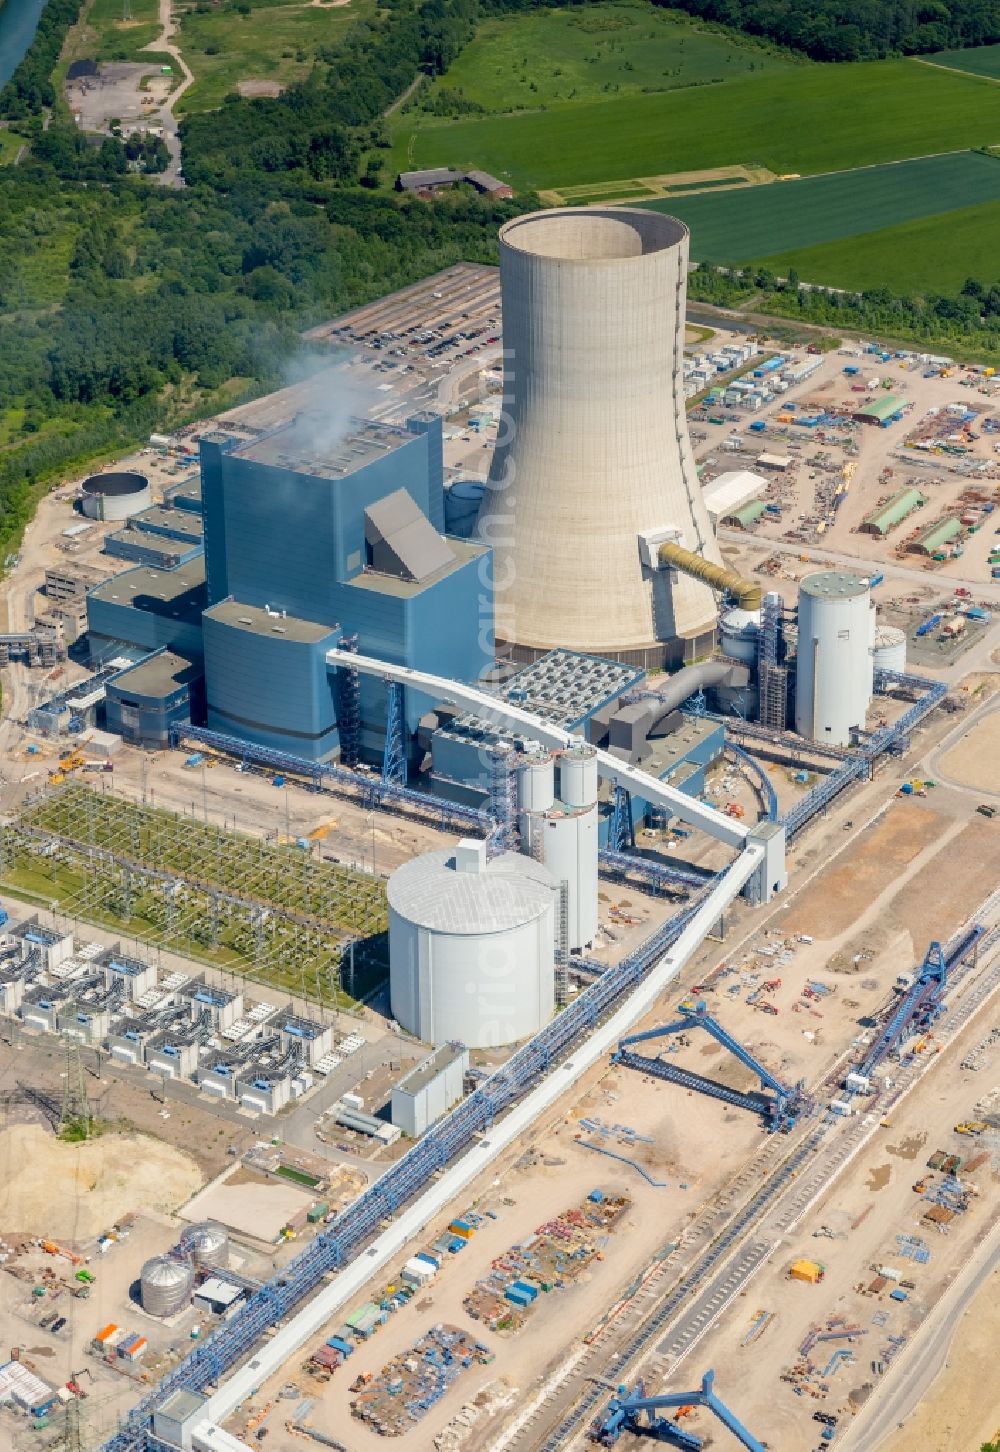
[202,611,340,761]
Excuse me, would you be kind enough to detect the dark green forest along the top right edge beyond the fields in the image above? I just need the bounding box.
[653,0,1000,61]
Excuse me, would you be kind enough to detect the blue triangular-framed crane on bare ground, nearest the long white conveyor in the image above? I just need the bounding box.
[611,999,808,1134]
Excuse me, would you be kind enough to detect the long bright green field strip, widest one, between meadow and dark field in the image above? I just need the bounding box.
[395,61,1000,189]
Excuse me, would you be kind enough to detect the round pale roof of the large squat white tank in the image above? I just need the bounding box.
[388,844,554,934]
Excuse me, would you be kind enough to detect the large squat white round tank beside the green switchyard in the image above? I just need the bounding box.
[388,842,557,1048]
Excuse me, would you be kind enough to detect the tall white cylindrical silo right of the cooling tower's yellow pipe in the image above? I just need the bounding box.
[795,569,875,746]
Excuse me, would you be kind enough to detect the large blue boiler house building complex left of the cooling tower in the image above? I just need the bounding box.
[89,412,493,761]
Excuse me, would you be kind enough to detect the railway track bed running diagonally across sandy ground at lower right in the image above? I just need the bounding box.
[507,917,1000,1452]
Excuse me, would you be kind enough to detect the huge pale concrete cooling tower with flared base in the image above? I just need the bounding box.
[478,208,720,665]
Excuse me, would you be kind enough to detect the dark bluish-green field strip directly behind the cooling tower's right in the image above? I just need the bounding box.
[642,151,1000,264]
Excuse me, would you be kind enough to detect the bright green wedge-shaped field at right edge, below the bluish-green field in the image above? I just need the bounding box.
[755,202,1000,293]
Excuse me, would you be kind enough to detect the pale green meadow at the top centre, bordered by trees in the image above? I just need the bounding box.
[421,3,794,112]
